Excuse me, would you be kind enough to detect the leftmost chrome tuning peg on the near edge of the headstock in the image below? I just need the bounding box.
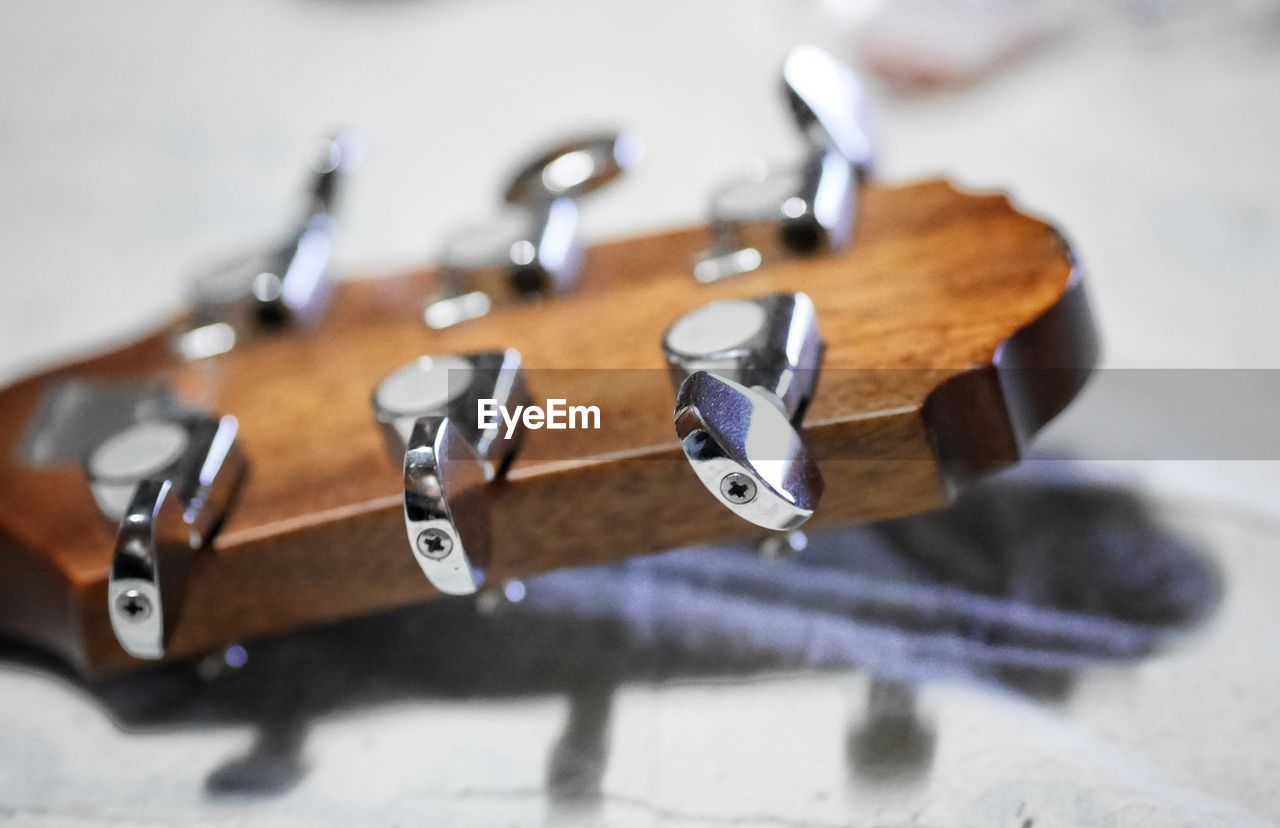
[84,415,246,659]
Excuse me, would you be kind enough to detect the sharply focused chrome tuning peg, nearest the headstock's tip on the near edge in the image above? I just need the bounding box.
[663,293,823,530]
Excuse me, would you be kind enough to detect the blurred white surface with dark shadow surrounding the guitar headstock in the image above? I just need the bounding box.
[0,0,1280,827]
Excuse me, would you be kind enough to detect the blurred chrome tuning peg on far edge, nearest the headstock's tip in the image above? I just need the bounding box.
[694,46,874,282]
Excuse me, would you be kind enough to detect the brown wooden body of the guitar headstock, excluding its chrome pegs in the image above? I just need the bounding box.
[0,182,1096,674]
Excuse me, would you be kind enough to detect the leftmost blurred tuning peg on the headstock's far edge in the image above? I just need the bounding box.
[175,132,364,360]
